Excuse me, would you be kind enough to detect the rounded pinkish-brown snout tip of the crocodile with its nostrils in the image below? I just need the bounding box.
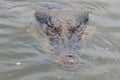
[57,53,80,69]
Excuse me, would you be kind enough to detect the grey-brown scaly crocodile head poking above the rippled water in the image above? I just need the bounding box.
[34,4,89,68]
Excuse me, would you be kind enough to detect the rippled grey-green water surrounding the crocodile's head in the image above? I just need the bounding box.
[0,0,120,80]
